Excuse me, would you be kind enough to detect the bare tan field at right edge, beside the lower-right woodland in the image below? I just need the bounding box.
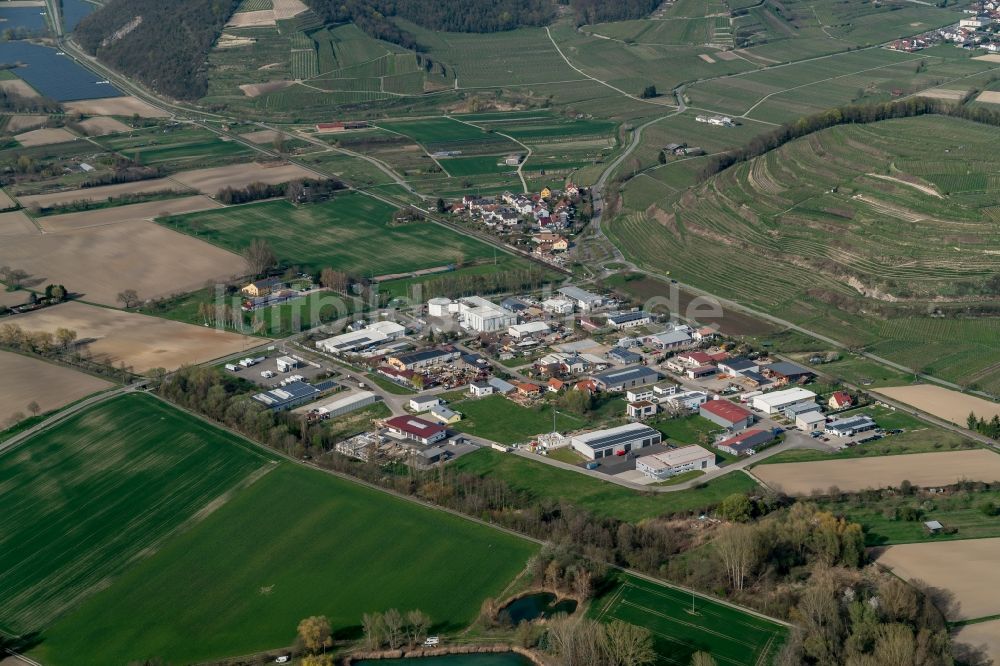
[875,538,1000,622]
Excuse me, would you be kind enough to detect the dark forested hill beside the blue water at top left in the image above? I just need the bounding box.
[74,0,239,100]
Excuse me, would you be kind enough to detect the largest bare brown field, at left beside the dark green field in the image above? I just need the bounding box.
[0,220,246,306]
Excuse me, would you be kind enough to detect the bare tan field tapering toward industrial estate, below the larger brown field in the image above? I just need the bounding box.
[6,302,258,372]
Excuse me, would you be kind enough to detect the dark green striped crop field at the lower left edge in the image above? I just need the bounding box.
[0,395,271,636]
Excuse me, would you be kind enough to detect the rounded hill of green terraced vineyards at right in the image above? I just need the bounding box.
[610,117,1000,391]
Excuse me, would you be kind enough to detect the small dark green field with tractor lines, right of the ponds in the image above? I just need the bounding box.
[588,574,788,666]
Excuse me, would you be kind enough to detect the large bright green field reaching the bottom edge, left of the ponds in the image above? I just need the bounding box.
[32,463,537,666]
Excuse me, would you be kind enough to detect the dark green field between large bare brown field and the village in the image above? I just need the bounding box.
[159,194,508,277]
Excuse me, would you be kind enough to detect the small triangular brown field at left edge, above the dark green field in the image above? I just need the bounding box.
[0,351,111,424]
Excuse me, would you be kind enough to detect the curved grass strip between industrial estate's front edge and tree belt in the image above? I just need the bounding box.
[450,448,757,522]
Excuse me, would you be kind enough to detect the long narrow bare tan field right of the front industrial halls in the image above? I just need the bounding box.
[753,449,1000,495]
